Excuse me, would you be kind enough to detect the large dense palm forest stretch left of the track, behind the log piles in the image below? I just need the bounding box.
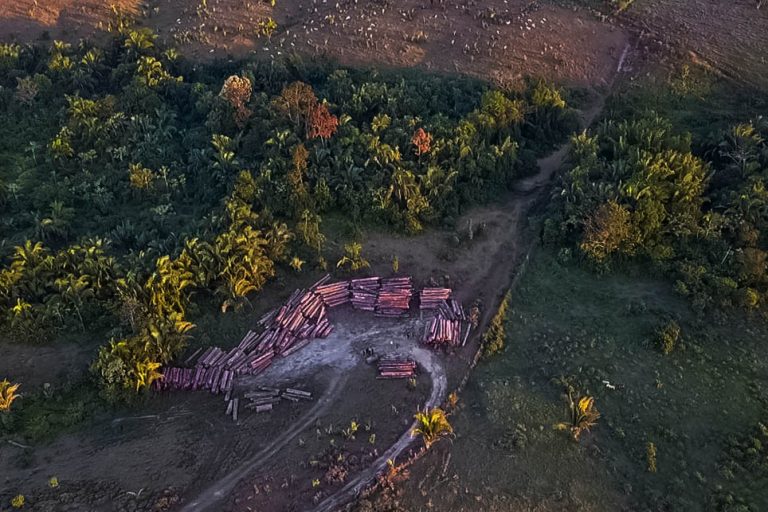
[0,27,577,398]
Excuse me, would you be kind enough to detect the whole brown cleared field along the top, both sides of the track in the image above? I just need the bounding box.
[0,0,768,86]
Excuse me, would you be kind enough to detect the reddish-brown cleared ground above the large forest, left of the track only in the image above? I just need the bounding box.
[0,0,628,85]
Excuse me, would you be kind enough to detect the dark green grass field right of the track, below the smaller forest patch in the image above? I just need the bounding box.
[404,249,768,511]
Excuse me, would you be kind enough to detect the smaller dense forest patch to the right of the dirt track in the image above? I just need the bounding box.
[545,112,768,312]
